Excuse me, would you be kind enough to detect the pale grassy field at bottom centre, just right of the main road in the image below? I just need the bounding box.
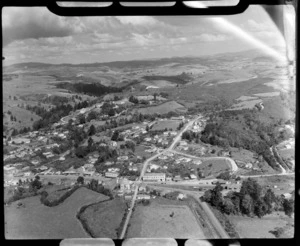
[127,198,205,238]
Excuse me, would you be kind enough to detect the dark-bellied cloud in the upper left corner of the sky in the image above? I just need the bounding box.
[2,7,85,46]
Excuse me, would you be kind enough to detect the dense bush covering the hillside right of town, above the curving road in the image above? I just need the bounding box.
[199,110,285,171]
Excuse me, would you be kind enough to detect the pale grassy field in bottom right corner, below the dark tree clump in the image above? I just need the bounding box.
[228,212,294,238]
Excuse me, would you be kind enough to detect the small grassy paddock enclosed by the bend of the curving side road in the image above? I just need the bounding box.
[199,159,231,177]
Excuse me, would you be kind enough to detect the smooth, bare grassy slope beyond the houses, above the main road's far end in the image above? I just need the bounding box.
[137,101,186,114]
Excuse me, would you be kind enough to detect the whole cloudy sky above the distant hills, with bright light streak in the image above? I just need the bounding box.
[2,5,285,66]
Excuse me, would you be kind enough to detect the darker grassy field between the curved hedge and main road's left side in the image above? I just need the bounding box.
[80,198,126,239]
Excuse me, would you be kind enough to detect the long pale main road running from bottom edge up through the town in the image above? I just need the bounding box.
[120,115,202,239]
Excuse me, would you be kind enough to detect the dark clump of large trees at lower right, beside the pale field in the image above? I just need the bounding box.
[201,178,294,218]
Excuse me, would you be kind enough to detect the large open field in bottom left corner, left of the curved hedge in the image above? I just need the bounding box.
[5,188,108,239]
